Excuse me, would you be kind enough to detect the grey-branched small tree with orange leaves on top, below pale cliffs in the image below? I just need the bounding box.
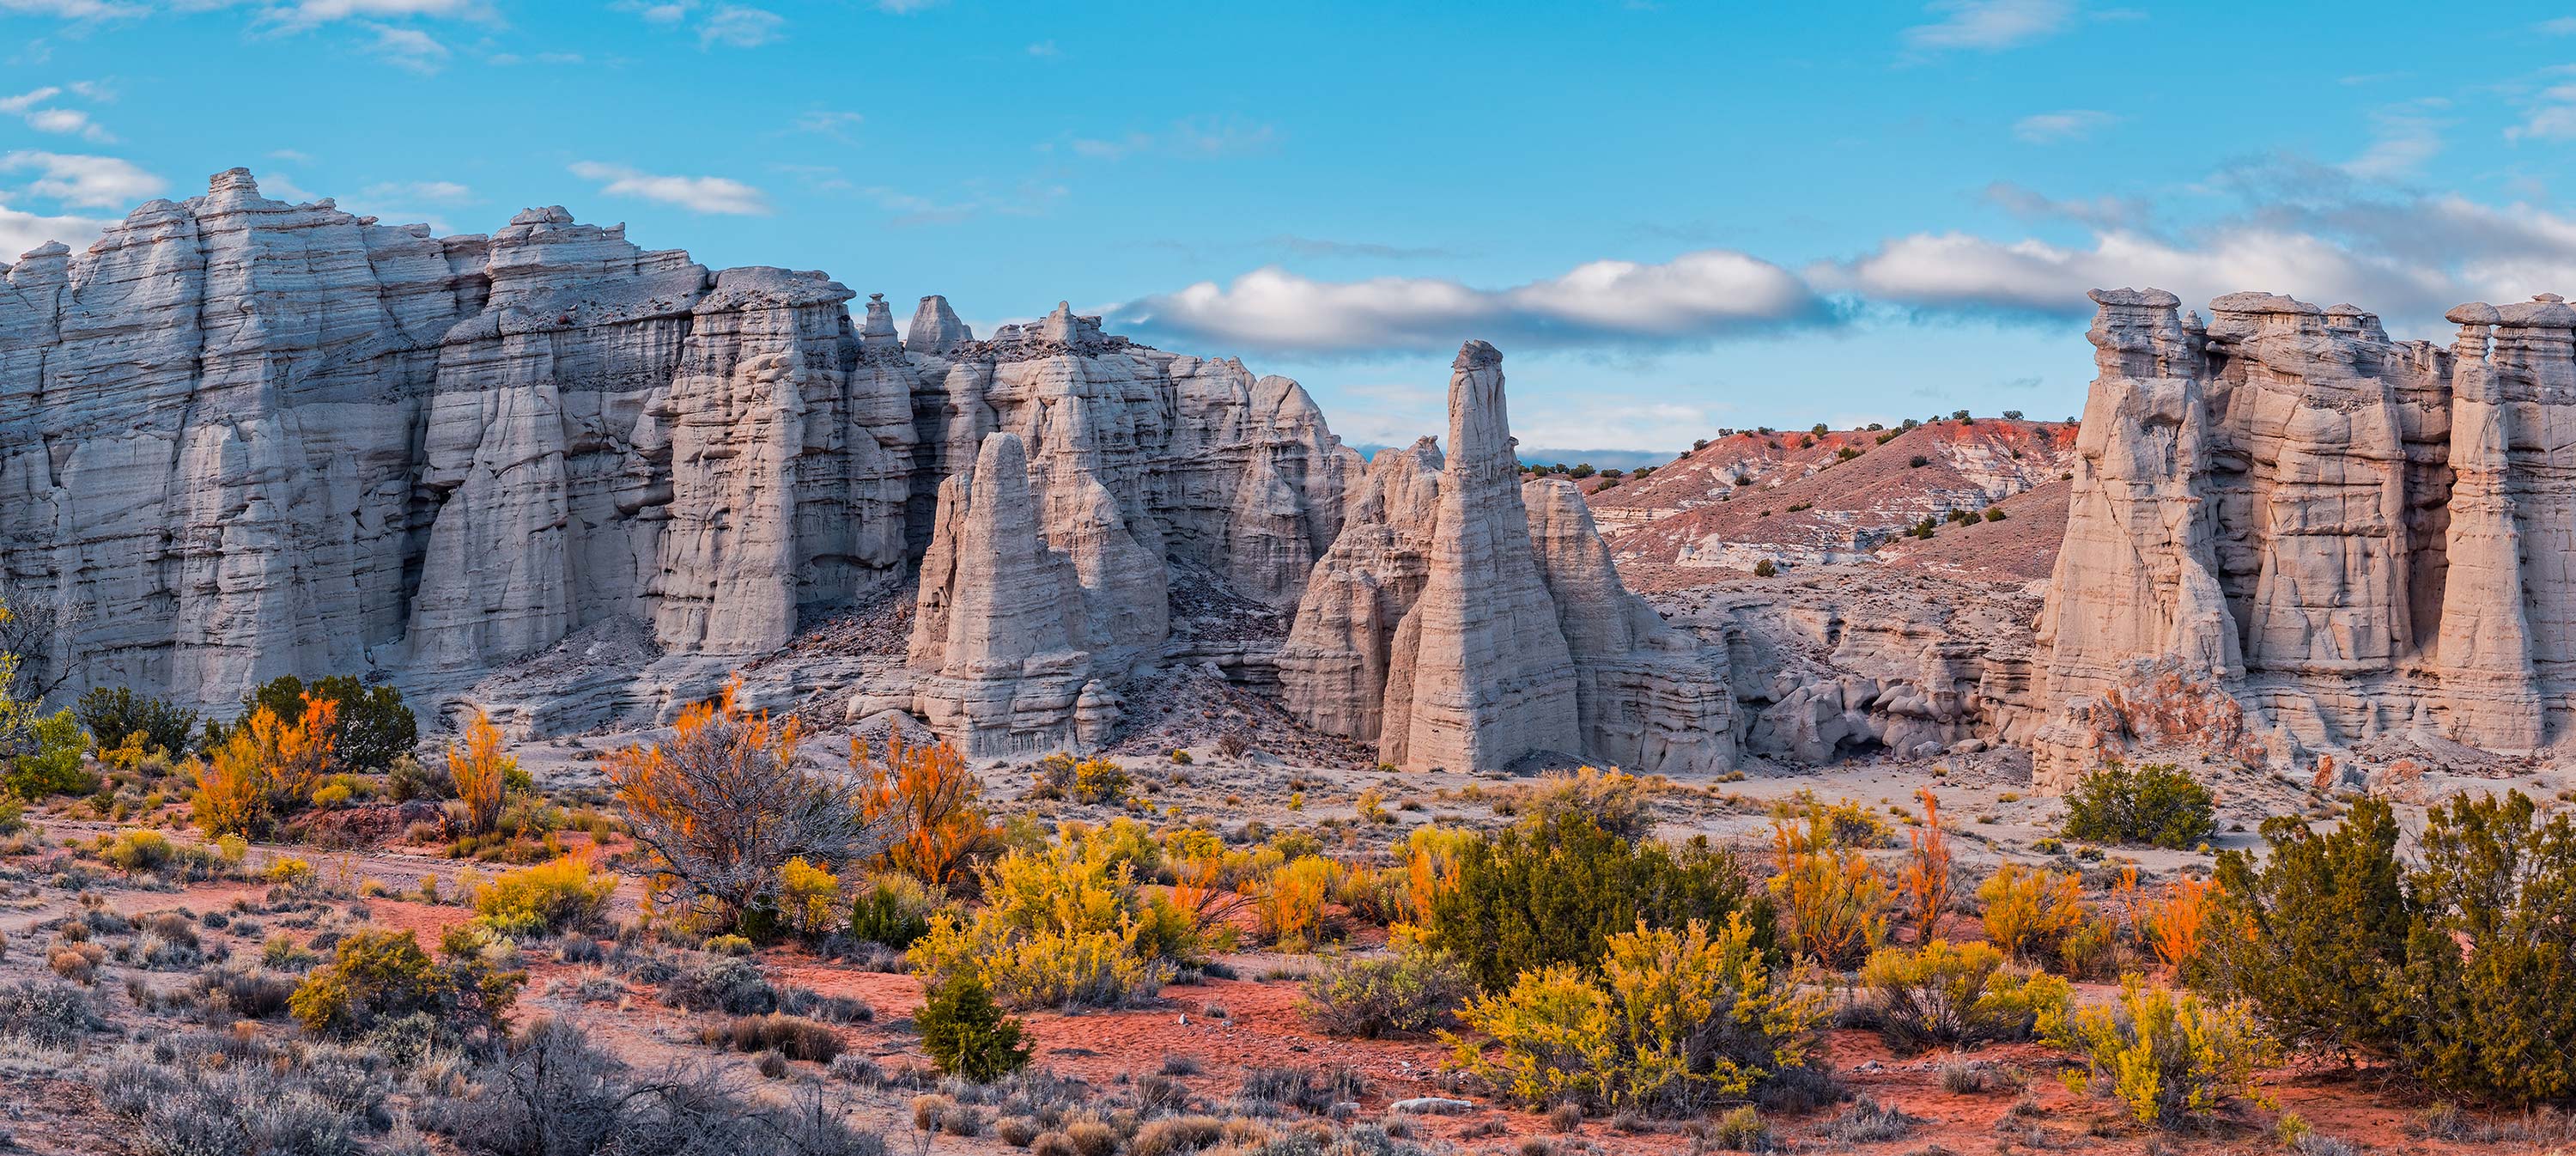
[605,684,886,927]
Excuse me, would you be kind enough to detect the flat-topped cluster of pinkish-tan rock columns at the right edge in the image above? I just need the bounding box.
[2035,291,2576,785]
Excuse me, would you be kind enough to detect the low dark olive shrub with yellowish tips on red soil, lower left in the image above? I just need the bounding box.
[286,932,528,1037]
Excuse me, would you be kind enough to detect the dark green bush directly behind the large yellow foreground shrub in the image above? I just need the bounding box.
[1427,813,1772,991]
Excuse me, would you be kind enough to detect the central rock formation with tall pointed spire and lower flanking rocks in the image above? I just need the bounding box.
[1280,343,1734,772]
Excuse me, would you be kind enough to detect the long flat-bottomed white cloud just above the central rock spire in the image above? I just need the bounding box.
[1113,250,1824,353]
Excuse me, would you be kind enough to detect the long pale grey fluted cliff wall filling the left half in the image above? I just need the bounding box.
[0,170,1360,744]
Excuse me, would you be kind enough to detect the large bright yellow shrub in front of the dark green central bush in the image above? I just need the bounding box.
[1445,911,1824,1112]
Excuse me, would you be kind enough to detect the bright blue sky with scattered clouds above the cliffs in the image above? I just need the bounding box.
[0,0,2576,451]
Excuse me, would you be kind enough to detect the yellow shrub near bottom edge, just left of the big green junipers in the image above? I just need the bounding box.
[2040,976,2280,1125]
